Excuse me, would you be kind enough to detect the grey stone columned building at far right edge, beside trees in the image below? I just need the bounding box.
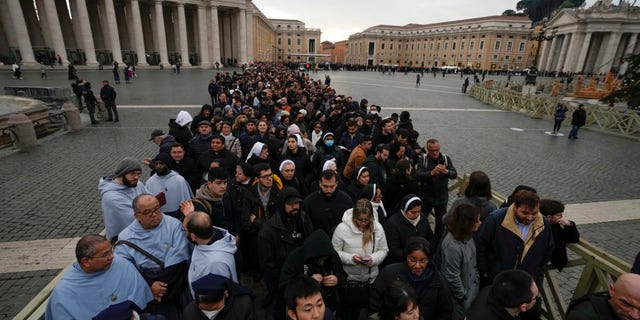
[538,1,640,74]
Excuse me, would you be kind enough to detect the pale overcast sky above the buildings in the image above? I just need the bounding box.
[253,0,596,42]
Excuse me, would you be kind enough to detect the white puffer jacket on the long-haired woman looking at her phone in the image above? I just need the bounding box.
[331,209,389,283]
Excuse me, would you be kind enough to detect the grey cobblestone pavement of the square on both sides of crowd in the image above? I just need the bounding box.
[0,70,640,319]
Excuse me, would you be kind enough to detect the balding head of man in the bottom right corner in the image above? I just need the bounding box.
[609,273,640,320]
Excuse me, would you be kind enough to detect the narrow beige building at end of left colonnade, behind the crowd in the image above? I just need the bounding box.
[270,19,322,63]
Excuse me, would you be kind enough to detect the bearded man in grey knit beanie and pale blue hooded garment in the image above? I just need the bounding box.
[98,158,148,243]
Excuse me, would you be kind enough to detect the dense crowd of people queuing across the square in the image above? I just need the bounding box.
[46,60,640,320]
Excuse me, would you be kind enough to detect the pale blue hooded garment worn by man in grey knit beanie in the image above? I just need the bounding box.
[98,176,148,239]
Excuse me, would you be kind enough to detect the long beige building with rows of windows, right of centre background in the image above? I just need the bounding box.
[345,16,533,70]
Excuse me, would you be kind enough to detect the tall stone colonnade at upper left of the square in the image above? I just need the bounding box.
[0,0,253,68]
